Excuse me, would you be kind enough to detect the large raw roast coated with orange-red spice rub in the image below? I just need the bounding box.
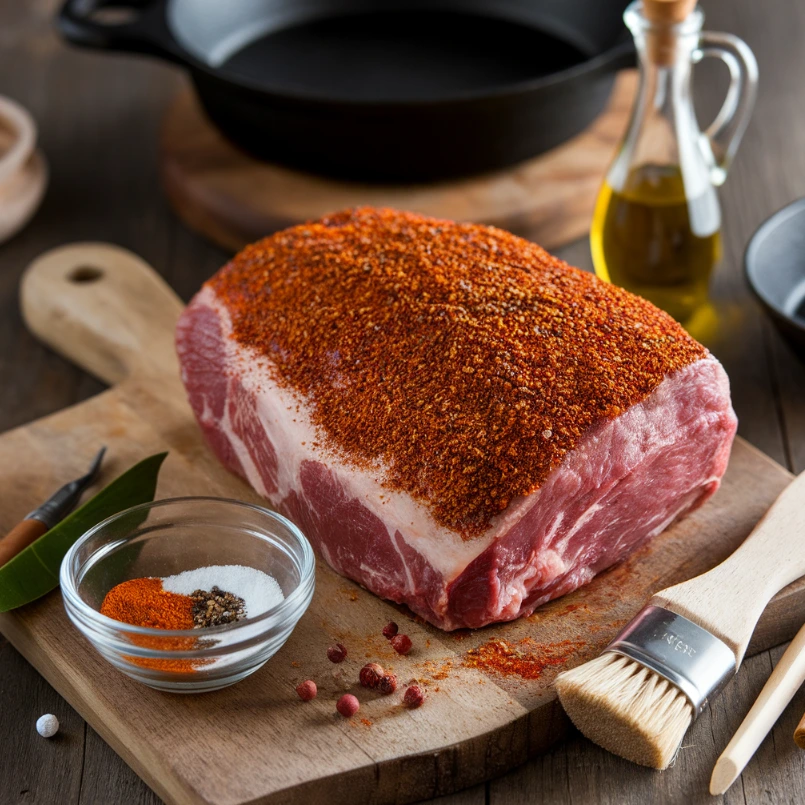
[176,209,736,629]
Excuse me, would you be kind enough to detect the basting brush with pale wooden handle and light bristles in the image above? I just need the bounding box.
[555,473,805,769]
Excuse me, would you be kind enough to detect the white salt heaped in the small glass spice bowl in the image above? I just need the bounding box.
[162,565,285,618]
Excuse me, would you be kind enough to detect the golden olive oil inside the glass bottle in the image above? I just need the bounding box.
[590,164,721,322]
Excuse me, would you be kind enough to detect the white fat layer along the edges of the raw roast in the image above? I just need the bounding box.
[196,287,717,584]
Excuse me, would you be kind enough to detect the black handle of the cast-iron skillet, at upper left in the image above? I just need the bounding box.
[56,0,184,63]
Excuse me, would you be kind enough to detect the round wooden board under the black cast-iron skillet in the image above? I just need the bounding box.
[160,70,637,251]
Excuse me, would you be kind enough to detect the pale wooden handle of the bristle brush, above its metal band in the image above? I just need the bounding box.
[651,473,805,665]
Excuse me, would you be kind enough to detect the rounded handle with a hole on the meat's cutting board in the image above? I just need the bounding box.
[20,243,182,384]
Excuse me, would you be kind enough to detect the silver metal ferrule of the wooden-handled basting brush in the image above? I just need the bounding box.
[605,606,737,718]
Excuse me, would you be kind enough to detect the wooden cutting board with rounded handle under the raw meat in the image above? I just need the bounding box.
[0,244,805,805]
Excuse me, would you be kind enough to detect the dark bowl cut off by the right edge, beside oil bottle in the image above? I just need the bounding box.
[744,198,805,357]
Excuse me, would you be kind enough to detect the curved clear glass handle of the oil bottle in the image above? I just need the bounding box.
[692,31,758,186]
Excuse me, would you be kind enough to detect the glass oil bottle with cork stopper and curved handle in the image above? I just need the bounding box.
[590,0,757,323]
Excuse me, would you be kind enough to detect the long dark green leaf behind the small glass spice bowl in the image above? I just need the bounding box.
[0,453,168,612]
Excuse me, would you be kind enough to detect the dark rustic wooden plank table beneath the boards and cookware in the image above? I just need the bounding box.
[0,0,805,805]
